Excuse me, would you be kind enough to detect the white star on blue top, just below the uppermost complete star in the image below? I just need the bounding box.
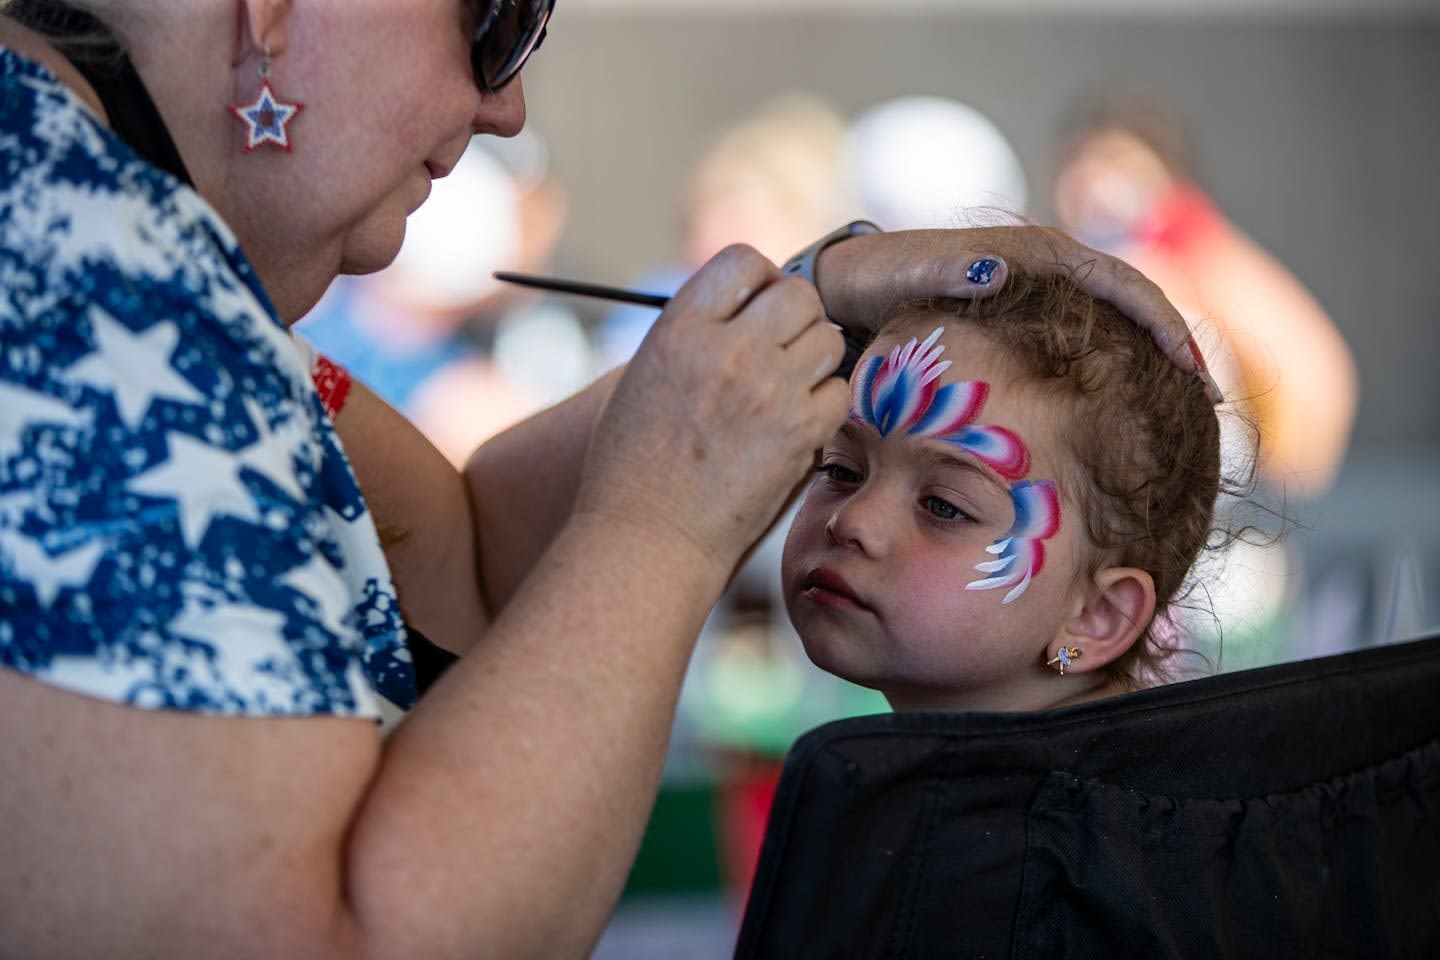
[128,432,259,547]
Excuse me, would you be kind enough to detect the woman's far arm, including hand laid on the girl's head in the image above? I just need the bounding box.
[357,226,1218,641]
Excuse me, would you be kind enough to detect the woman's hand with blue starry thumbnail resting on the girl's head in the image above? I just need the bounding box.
[815,226,1220,403]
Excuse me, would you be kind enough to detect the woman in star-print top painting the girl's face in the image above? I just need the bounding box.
[0,0,1215,959]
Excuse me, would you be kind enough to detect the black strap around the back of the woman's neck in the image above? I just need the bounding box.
[4,0,194,187]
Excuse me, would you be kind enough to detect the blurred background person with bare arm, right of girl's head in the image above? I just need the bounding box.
[1054,91,1359,499]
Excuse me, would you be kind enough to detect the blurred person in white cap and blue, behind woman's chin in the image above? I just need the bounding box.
[297,127,595,465]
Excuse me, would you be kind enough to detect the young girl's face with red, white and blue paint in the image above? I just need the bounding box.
[782,325,1083,710]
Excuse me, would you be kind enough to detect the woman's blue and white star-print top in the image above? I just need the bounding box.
[0,49,415,717]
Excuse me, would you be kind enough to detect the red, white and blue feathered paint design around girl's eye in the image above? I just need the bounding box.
[850,327,1060,603]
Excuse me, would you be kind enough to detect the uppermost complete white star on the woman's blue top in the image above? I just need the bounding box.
[63,307,204,427]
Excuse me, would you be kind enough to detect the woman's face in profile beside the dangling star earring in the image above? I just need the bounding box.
[225,0,526,320]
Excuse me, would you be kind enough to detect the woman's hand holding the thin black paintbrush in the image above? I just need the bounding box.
[576,246,848,567]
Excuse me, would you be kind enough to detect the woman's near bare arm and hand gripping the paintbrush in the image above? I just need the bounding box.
[0,244,848,960]
